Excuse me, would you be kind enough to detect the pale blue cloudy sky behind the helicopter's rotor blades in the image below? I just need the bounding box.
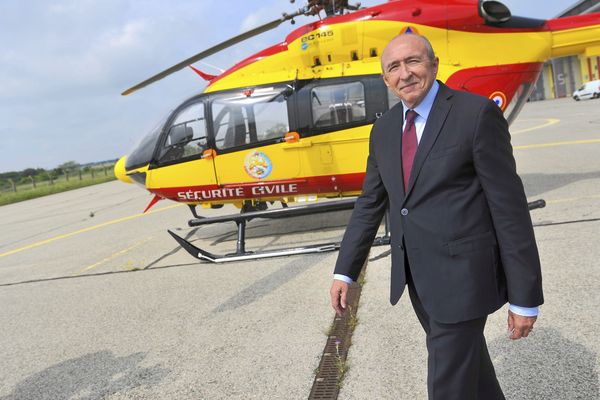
[0,0,576,172]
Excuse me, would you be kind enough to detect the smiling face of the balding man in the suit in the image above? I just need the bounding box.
[381,34,439,108]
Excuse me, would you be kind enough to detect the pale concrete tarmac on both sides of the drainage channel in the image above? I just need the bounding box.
[0,99,600,400]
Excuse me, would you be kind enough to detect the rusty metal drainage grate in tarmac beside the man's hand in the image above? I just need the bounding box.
[308,262,367,400]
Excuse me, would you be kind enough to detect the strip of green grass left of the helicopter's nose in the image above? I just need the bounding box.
[0,171,116,206]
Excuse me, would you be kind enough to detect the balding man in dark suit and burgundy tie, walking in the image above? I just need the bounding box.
[331,34,543,400]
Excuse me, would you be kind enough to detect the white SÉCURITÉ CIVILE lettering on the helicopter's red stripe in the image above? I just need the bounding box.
[177,183,298,201]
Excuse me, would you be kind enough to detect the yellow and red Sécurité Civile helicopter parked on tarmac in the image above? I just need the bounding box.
[115,0,600,262]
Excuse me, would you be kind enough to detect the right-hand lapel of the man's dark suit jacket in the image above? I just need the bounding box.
[405,82,452,198]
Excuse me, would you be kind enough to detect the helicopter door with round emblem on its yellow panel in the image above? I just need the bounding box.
[211,85,300,198]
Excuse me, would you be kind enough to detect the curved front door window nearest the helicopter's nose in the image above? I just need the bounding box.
[160,103,206,162]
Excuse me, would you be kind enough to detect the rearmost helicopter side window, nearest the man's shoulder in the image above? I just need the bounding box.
[310,82,366,128]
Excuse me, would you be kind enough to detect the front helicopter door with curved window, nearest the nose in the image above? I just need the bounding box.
[146,99,216,197]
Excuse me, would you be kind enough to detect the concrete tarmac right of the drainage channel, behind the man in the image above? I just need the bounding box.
[339,99,600,400]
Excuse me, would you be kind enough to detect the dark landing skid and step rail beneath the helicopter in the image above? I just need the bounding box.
[168,199,546,263]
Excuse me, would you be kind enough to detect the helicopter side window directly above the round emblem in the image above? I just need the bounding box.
[212,86,289,149]
